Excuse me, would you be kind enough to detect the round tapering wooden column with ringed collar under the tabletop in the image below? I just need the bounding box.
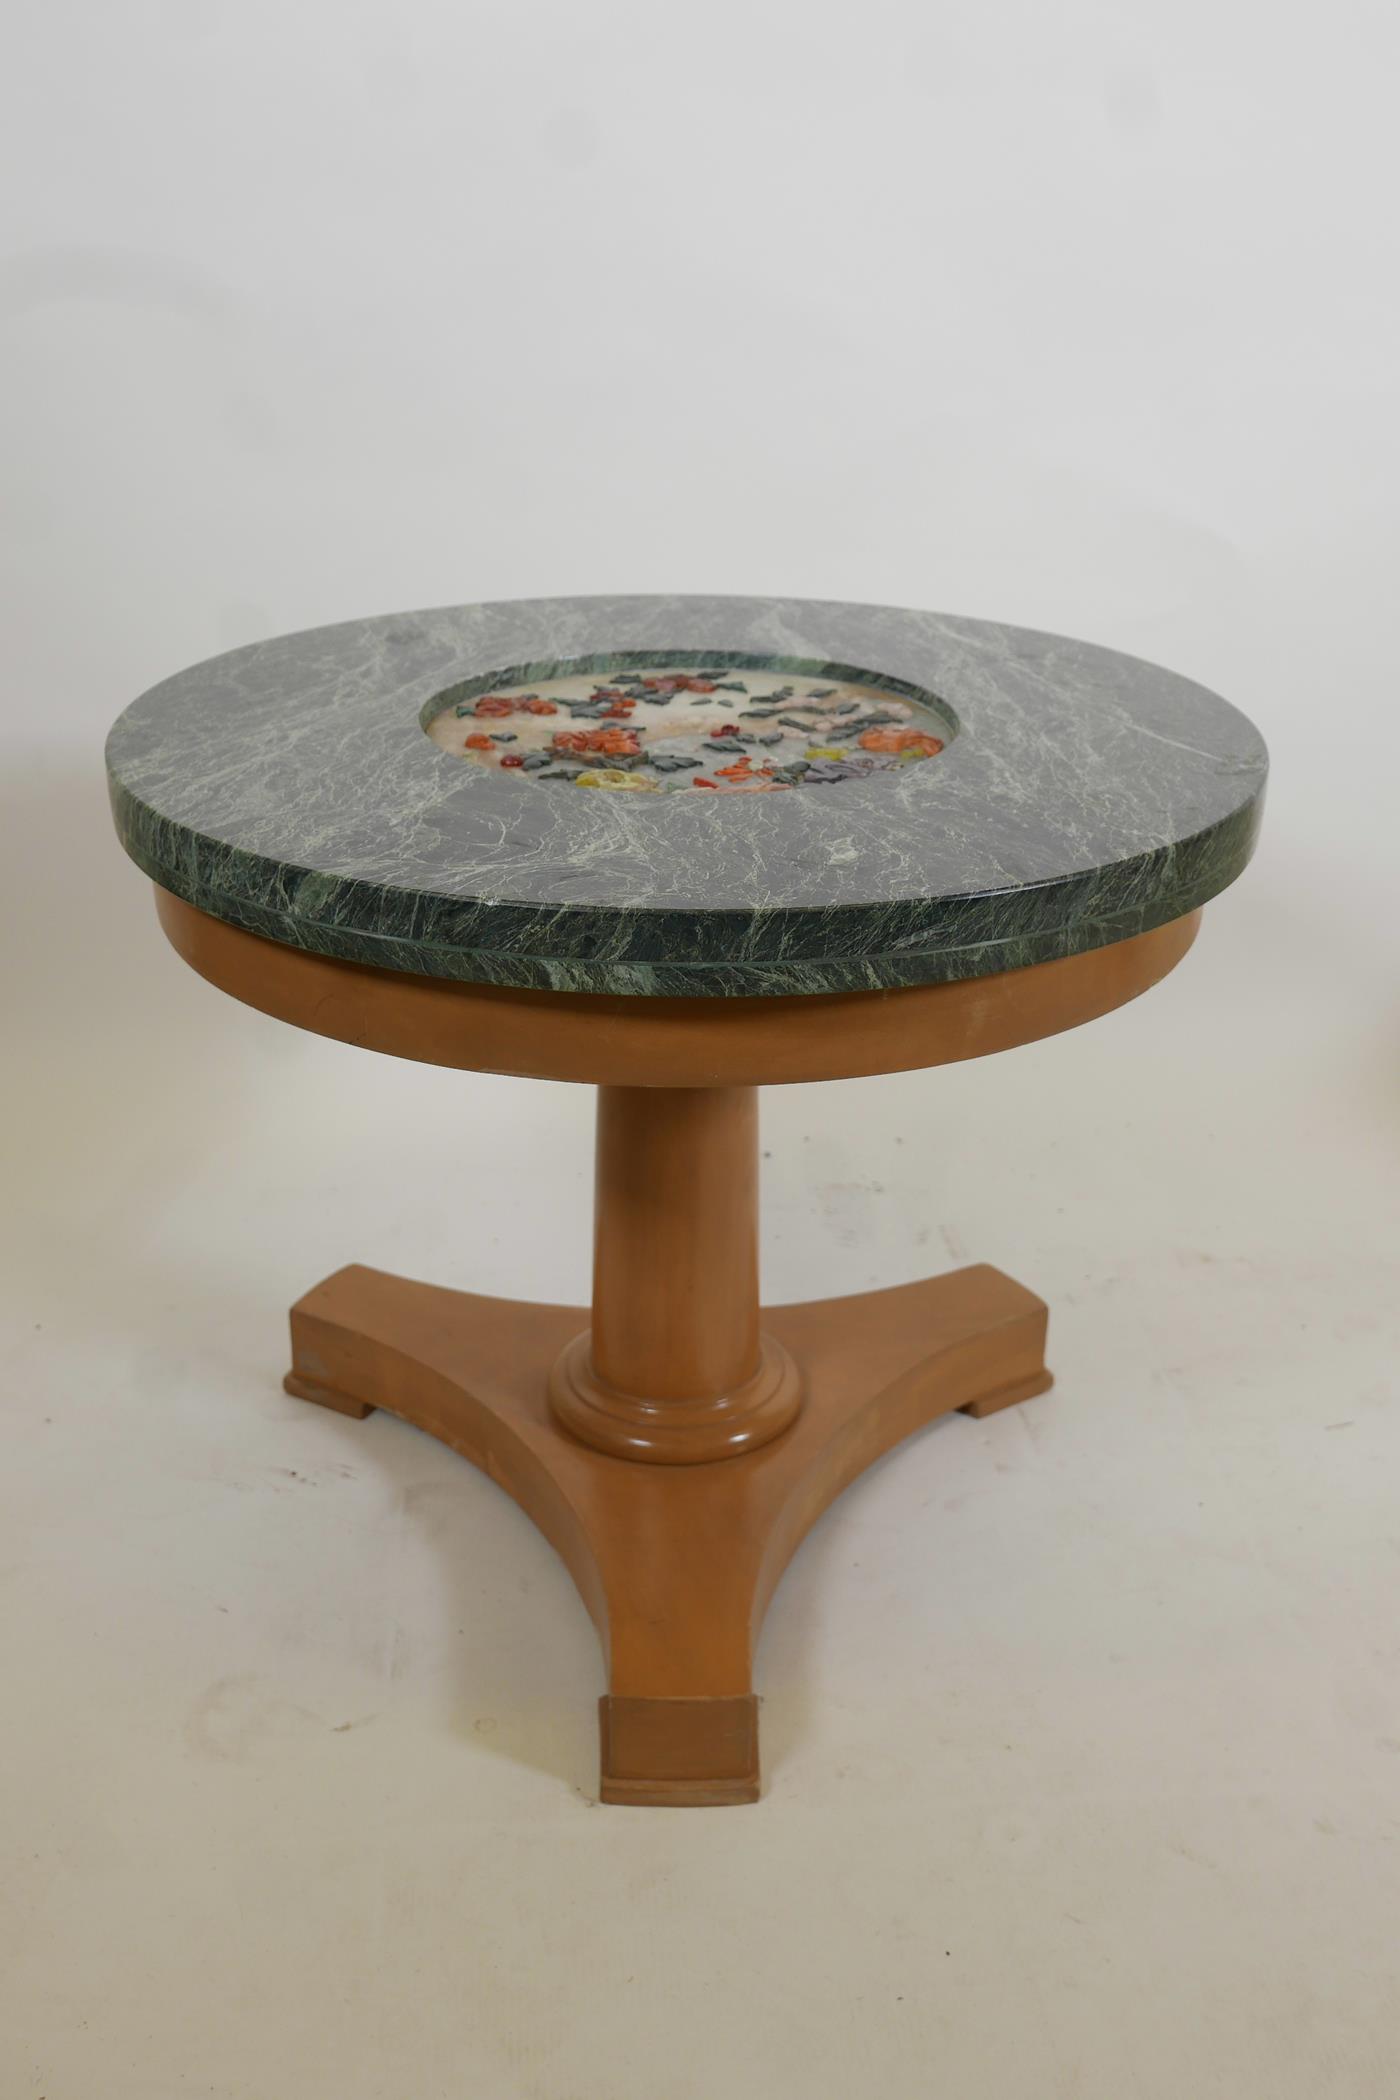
[550,1086,802,1464]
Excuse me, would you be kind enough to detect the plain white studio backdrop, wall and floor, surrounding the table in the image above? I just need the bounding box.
[0,0,1400,2100]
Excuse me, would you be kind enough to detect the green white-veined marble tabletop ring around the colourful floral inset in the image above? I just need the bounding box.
[107,596,1268,995]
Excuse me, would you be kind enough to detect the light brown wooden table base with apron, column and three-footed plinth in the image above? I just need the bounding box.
[155,888,1199,1806]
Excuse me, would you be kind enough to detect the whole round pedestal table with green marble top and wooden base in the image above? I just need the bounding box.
[107,596,1268,1804]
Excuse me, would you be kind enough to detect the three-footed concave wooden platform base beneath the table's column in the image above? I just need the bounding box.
[288,1266,1049,1806]
